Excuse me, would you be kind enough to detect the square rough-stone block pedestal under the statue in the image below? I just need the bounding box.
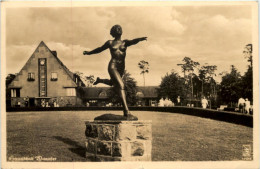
[85,120,152,161]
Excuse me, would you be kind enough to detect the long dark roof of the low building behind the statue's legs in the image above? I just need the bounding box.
[83,86,158,99]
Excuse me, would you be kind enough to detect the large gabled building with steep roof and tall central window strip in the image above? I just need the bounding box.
[8,41,84,107]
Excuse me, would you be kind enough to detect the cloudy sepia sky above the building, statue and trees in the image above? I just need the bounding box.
[6,5,252,85]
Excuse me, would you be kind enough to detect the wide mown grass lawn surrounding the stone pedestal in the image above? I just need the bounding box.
[7,111,253,161]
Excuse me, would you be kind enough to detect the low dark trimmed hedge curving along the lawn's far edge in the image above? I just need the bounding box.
[7,106,253,127]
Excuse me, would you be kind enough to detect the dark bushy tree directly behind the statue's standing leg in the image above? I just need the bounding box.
[108,70,137,106]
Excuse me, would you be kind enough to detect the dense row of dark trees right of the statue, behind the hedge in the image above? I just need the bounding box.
[158,44,253,107]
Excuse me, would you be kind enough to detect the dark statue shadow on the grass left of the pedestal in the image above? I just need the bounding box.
[53,136,86,158]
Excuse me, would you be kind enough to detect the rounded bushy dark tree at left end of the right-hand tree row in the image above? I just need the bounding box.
[158,71,187,103]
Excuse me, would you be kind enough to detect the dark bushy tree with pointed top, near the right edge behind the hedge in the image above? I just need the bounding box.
[219,65,243,104]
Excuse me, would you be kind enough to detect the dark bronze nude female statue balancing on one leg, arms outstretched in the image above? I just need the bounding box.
[83,25,147,120]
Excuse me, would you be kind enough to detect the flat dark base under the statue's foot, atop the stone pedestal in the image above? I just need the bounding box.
[94,114,138,121]
